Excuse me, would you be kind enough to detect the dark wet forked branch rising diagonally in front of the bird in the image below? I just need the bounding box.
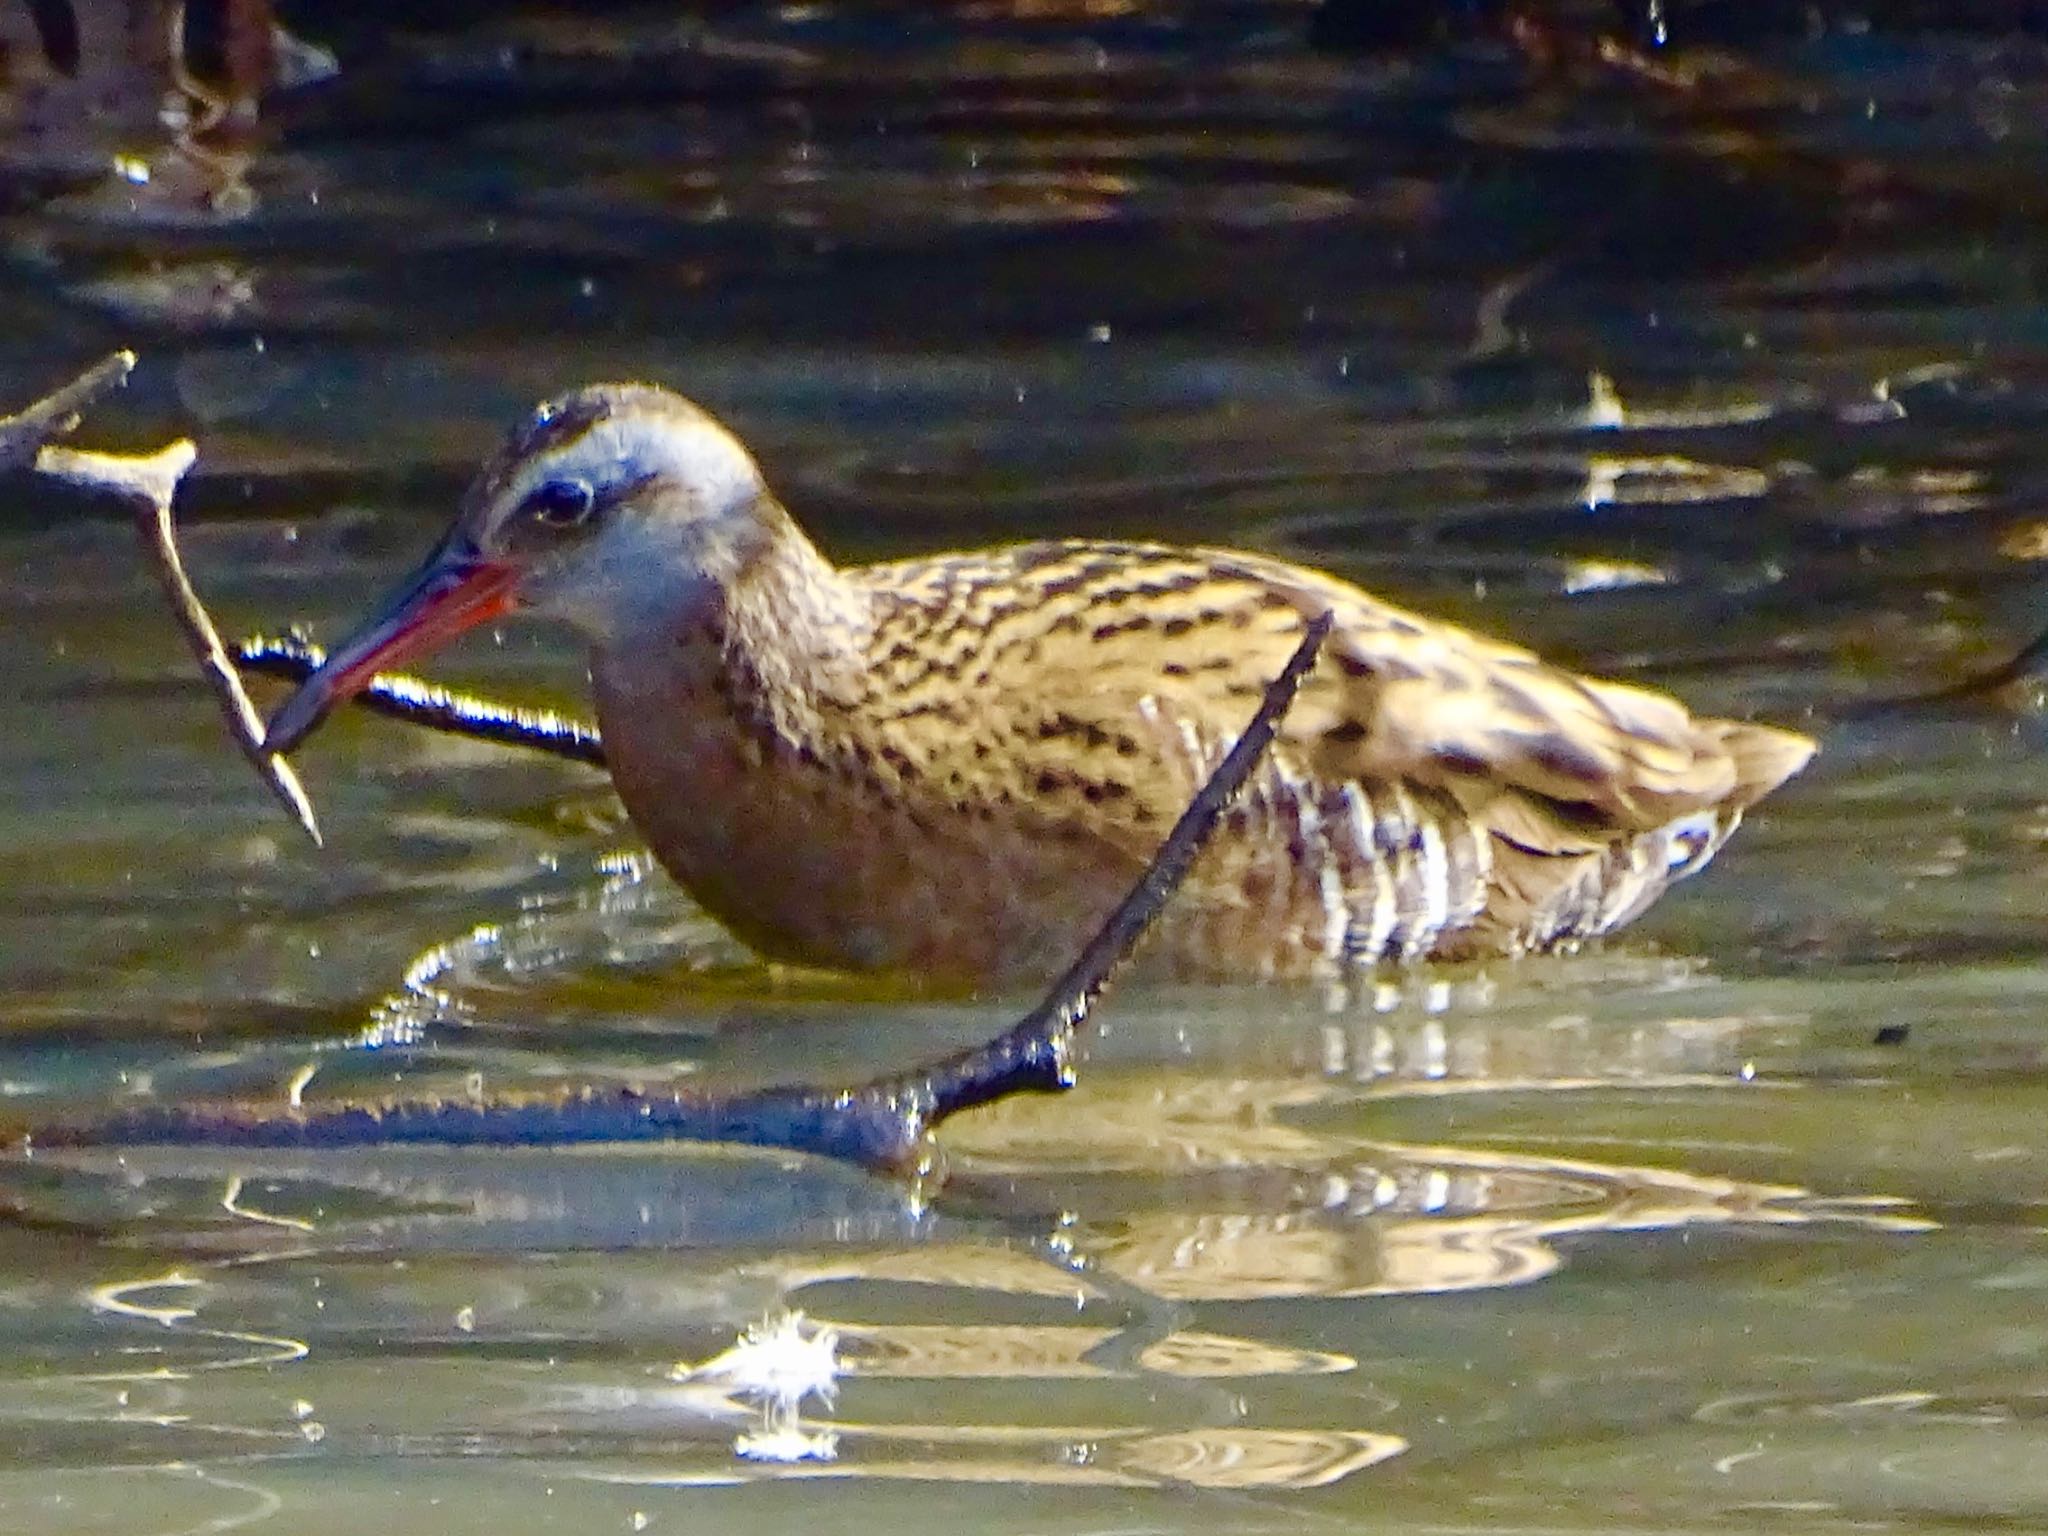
[18,614,1329,1171]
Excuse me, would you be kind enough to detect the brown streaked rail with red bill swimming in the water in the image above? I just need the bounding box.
[270,385,1812,981]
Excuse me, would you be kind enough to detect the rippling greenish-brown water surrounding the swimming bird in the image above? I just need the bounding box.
[0,4,2048,1536]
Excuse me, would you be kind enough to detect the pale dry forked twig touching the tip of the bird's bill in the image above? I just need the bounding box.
[0,352,319,844]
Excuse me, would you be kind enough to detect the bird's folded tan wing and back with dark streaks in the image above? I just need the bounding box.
[862,543,1812,868]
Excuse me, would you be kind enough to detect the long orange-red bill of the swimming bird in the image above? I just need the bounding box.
[262,545,518,752]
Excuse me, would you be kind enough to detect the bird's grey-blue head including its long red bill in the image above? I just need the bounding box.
[264,385,770,752]
